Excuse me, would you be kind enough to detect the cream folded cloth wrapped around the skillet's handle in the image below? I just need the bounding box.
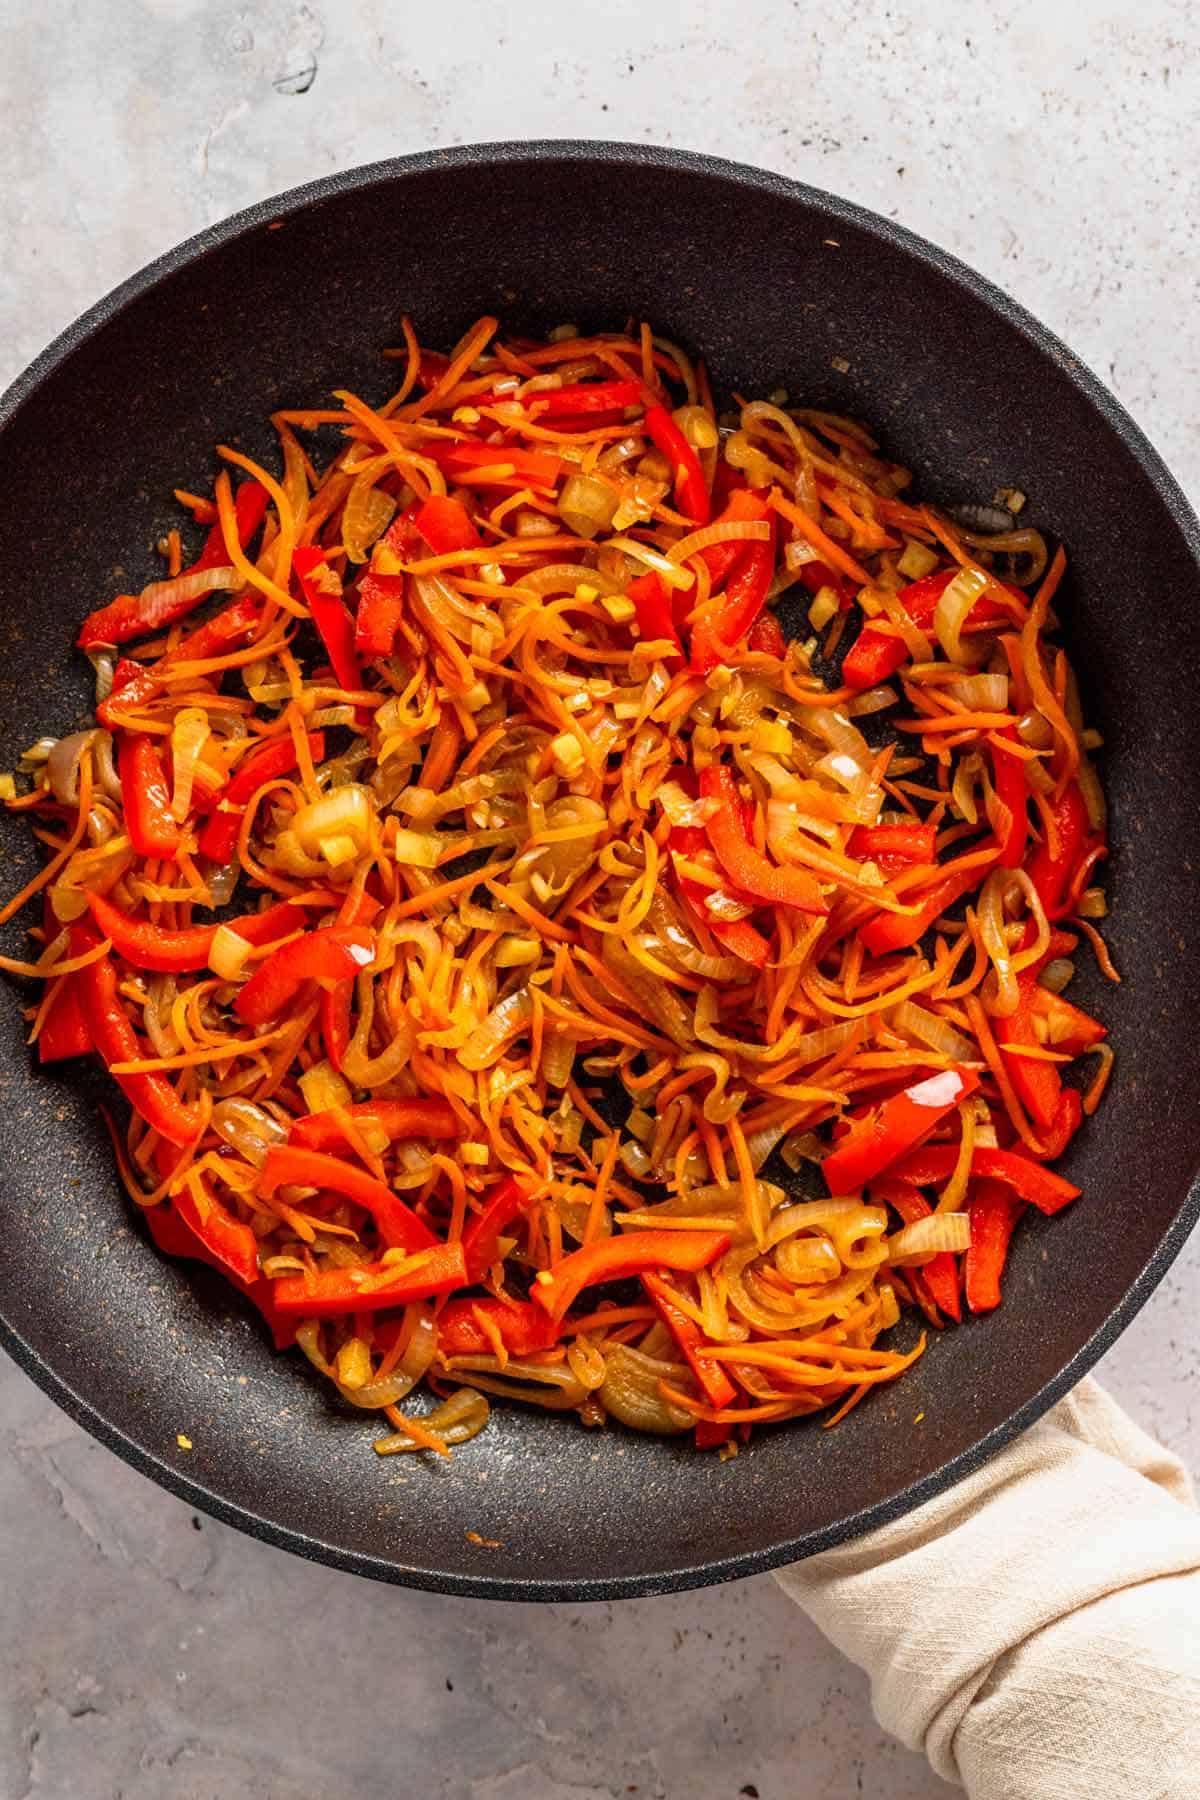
[777,1379,1200,1800]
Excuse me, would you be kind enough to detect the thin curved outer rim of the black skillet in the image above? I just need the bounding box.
[0,139,1200,1602]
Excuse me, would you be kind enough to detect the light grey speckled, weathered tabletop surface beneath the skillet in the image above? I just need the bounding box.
[0,0,1200,1800]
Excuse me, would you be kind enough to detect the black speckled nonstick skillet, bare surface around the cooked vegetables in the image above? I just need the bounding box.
[0,144,1200,1600]
